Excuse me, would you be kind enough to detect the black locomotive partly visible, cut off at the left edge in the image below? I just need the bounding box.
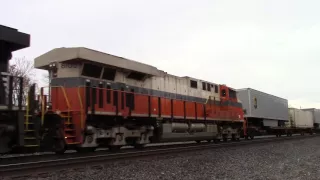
[0,25,34,154]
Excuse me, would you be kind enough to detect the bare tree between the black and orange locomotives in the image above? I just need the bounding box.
[9,57,34,104]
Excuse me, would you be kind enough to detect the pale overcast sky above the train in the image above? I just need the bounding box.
[0,0,320,108]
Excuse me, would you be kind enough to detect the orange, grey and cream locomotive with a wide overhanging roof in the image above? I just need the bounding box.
[35,47,245,153]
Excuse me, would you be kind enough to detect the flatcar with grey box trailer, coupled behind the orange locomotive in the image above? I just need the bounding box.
[237,88,289,139]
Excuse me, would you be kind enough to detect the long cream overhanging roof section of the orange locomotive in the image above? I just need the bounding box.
[34,47,162,76]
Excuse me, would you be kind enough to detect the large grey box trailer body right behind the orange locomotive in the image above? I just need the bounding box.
[237,88,289,127]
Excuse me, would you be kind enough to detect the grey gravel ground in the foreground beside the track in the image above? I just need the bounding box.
[0,137,320,180]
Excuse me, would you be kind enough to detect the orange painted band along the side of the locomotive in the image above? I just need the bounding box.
[51,87,243,126]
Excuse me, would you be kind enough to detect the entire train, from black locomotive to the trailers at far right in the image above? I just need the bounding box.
[0,24,318,153]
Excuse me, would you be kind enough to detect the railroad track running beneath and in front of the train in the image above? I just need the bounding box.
[0,134,320,177]
